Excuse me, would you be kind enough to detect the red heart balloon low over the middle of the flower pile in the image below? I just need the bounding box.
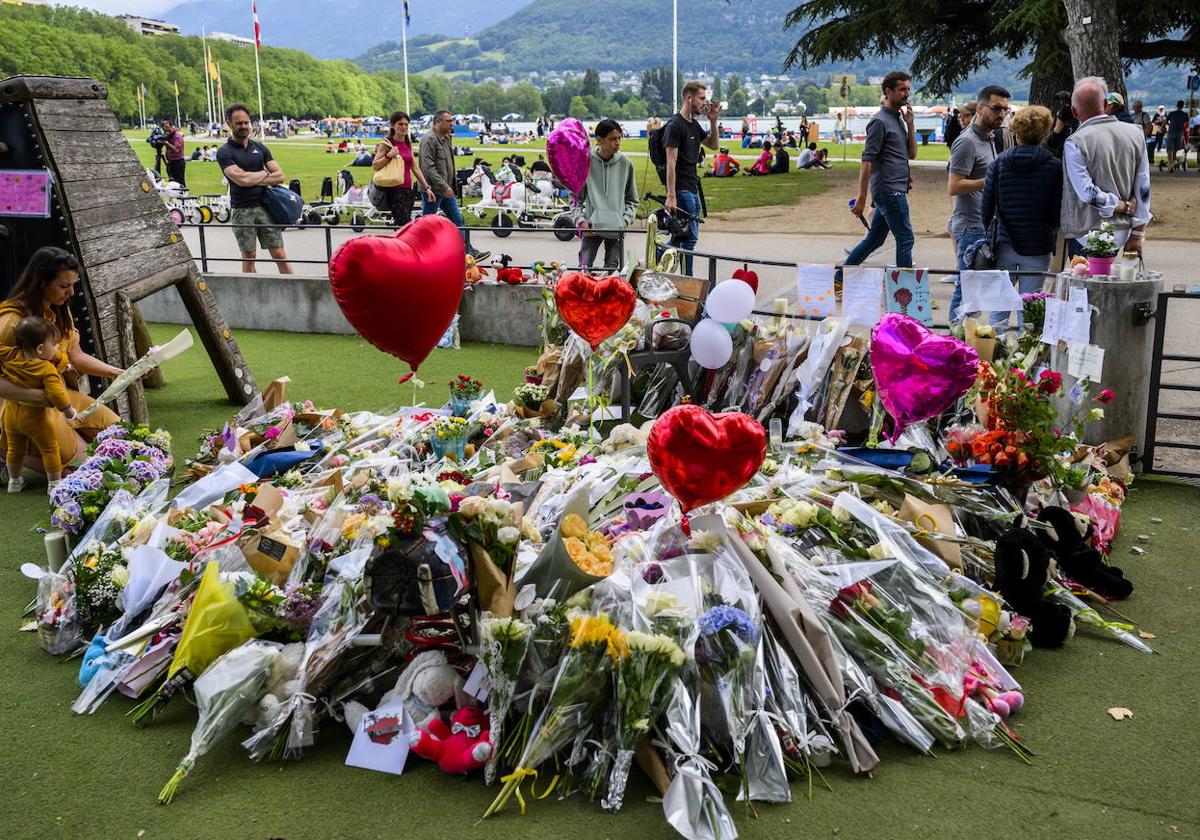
[646,406,767,514]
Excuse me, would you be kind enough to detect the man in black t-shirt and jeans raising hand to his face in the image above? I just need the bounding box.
[662,82,721,275]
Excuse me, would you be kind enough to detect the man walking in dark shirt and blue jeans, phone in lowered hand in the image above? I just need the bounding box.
[839,70,917,274]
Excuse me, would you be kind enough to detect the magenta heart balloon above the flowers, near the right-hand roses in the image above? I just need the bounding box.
[871,312,979,443]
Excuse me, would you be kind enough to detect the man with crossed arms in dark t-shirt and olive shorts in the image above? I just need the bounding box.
[217,103,294,274]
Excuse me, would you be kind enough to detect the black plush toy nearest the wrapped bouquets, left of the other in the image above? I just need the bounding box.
[995,528,1075,648]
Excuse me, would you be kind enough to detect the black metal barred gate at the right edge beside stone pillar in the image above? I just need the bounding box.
[1142,291,1200,479]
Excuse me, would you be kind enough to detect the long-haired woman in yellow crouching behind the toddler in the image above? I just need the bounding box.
[0,247,121,472]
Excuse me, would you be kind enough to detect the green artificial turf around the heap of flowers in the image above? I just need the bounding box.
[0,325,1200,840]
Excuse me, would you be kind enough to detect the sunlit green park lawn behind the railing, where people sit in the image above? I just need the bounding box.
[126,132,858,219]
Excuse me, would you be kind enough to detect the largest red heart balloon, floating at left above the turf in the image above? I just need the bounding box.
[329,216,467,371]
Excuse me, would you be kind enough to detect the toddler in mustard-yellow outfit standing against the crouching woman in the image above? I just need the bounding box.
[0,317,76,493]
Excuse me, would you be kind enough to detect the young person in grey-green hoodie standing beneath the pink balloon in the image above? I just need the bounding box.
[576,120,638,271]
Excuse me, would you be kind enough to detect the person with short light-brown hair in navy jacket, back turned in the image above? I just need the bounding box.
[983,106,1062,294]
